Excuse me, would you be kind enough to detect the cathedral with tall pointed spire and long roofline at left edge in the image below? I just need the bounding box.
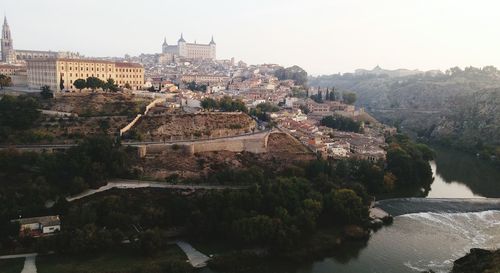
[1,17,80,64]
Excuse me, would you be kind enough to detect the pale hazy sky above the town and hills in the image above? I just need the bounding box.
[0,0,500,74]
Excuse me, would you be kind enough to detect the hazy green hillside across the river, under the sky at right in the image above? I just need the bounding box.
[309,66,500,156]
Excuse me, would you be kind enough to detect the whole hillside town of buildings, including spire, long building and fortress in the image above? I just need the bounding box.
[0,14,388,161]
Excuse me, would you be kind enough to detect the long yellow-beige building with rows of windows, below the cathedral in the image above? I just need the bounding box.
[27,58,144,91]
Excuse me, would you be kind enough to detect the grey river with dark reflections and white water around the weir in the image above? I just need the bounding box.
[296,148,500,273]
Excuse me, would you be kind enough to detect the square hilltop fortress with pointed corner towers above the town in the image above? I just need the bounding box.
[162,34,216,60]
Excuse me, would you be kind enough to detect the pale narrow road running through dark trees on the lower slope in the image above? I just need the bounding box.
[66,177,249,202]
